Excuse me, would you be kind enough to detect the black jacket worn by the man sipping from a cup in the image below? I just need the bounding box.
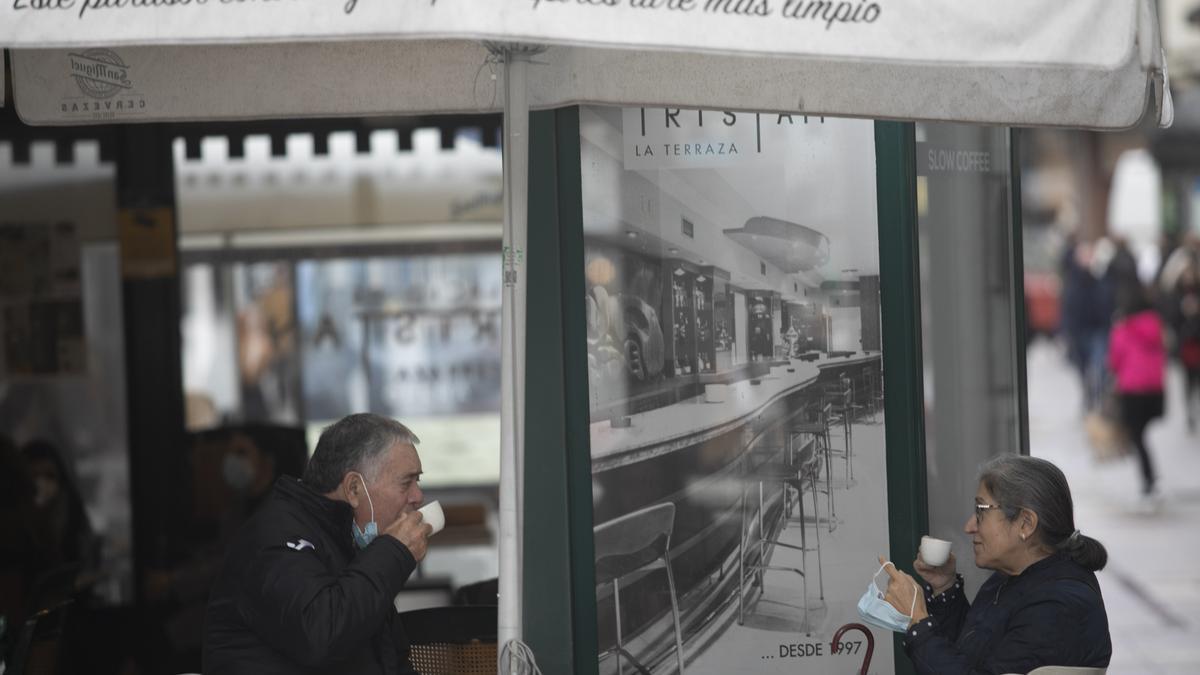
[204,477,416,675]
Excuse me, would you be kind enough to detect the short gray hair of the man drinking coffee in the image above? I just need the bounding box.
[302,412,421,494]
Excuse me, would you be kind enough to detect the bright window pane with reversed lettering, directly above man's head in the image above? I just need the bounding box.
[296,253,500,486]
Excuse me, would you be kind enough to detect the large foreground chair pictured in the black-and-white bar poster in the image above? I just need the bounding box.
[592,502,684,675]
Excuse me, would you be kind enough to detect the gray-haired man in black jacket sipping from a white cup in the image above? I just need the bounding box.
[204,414,431,675]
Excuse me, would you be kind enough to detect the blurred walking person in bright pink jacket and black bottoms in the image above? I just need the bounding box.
[1109,293,1166,498]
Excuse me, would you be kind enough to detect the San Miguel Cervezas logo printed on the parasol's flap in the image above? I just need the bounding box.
[60,48,146,119]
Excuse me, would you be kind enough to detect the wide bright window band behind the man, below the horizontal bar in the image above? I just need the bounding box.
[182,252,500,485]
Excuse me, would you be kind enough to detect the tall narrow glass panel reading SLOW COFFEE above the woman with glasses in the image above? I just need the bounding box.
[917,124,1024,585]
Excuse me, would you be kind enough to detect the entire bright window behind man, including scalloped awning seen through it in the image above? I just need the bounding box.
[175,125,503,486]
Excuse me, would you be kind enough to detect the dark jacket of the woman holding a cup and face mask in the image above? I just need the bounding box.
[904,552,1112,675]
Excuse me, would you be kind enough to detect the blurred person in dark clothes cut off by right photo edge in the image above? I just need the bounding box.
[1164,246,1200,434]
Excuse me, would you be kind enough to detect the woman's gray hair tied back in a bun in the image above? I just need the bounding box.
[979,455,1109,572]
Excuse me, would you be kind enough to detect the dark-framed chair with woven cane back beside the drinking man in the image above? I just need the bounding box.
[397,605,498,675]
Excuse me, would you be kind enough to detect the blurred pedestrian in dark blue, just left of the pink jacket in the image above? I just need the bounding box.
[1060,237,1116,413]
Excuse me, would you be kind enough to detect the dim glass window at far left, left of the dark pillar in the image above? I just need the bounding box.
[0,139,134,600]
